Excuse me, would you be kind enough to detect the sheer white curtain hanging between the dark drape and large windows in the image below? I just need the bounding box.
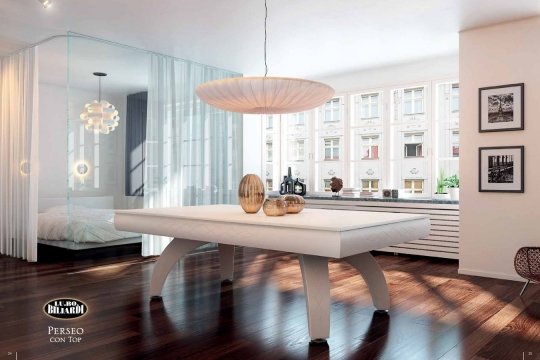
[142,55,242,256]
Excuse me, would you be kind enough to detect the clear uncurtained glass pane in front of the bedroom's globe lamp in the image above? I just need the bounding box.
[66,34,149,245]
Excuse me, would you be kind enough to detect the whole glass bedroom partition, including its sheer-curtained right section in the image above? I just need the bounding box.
[62,34,242,246]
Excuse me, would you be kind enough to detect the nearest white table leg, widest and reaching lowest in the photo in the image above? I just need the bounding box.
[300,255,330,343]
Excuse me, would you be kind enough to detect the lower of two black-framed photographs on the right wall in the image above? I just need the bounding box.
[478,146,525,193]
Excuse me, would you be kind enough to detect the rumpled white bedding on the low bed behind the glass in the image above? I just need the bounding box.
[38,206,140,243]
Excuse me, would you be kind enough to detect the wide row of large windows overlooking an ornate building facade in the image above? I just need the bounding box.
[261,79,460,196]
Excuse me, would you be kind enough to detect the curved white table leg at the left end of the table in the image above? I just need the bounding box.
[150,238,207,298]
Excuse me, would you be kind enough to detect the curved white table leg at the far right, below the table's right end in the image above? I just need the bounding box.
[343,252,390,311]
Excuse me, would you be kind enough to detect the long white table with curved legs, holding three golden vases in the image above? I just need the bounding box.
[115,205,429,342]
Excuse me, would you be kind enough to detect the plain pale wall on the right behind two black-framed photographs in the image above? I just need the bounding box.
[459,17,540,279]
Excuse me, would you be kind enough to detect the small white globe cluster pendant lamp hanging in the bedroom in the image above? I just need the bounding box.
[81,72,120,134]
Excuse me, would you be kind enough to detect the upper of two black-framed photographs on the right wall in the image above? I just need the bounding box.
[479,83,525,132]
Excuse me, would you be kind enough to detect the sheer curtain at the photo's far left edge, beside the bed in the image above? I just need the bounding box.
[0,48,39,261]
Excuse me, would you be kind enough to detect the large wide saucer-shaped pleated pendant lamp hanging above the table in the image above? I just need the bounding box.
[195,0,334,114]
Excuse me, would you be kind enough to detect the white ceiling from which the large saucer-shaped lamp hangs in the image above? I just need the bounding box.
[0,0,540,78]
